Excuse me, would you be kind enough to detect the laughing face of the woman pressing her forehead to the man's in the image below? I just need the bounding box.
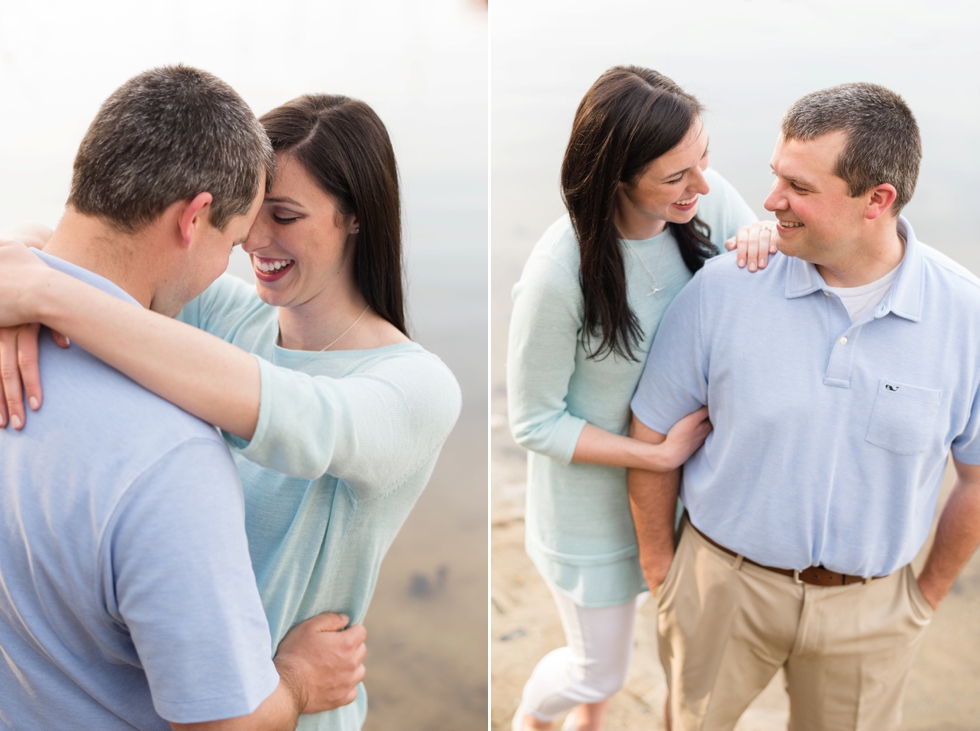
[242,152,358,307]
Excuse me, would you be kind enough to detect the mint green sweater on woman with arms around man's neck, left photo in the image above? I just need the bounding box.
[180,275,461,731]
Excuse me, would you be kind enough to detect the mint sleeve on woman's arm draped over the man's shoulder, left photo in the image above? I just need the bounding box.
[233,348,461,498]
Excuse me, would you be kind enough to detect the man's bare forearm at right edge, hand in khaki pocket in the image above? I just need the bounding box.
[919,465,980,608]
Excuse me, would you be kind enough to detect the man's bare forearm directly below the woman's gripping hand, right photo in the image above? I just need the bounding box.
[626,469,681,591]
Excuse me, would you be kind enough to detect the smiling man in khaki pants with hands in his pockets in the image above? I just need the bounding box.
[629,84,980,731]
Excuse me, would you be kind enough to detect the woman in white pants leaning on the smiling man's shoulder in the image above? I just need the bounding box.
[507,66,761,731]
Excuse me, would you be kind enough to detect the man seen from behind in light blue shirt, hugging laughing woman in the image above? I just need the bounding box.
[0,66,364,731]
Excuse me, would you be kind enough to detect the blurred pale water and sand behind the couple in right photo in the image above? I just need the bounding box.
[490,0,980,731]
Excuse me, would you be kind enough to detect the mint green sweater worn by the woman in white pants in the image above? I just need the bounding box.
[507,169,758,607]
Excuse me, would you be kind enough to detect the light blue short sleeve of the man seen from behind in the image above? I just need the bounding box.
[100,437,279,723]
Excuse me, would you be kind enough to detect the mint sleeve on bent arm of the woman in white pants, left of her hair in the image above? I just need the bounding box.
[507,253,586,464]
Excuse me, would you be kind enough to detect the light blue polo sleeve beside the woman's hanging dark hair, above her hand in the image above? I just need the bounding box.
[630,269,708,434]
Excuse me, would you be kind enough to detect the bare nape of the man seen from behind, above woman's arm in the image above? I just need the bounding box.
[44,207,156,308]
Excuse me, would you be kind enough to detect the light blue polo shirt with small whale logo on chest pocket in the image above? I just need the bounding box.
[632,217,980,576]
